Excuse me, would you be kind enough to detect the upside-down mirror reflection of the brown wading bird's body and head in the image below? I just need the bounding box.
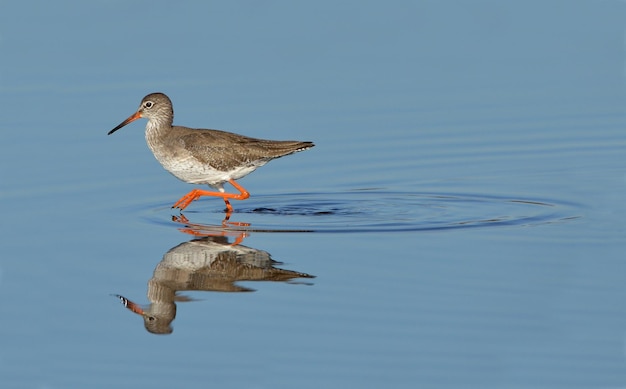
[115,236,315,334]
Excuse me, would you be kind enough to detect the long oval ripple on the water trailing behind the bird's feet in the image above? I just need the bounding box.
[139,189,580,233]
